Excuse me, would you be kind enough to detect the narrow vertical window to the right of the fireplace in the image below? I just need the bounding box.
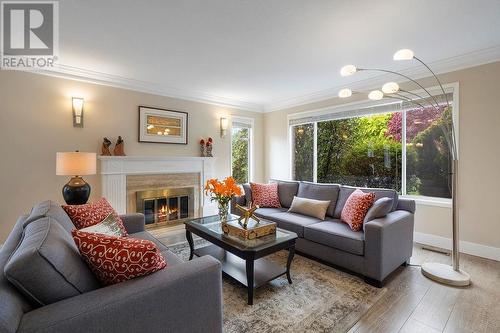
[231,119,252,184]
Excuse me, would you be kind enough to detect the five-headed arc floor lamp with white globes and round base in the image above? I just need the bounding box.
[338,49,470,286]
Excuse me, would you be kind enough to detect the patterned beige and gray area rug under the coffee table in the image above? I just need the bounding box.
[169,240,386,333]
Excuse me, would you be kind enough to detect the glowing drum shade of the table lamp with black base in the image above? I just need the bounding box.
[56,152,97,176]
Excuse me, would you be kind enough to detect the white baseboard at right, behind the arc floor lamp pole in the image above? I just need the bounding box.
[413,232,500,261]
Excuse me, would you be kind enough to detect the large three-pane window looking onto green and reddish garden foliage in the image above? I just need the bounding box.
[290,94,452,198]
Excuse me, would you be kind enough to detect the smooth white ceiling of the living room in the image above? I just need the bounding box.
[49,0,500,111]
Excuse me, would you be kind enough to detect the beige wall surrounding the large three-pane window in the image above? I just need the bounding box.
[264,62,500,248]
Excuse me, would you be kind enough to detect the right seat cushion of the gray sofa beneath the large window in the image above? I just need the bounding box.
[304,218,365,255]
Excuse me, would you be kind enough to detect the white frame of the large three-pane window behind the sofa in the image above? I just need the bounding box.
[286,82,460,208]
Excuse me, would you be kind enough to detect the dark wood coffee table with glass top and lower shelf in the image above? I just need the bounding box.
[184,215,297,305]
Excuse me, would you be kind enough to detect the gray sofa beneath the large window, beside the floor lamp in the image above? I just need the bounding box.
[231,181,415,287]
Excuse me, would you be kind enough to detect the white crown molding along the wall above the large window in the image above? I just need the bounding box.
[264,45,500,112]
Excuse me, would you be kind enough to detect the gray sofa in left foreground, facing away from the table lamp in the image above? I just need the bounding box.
[0,201,222,333]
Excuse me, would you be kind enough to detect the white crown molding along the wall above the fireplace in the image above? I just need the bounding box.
[35,64,264,112]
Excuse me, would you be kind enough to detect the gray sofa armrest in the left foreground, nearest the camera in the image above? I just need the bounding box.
[18,256,222,333]
